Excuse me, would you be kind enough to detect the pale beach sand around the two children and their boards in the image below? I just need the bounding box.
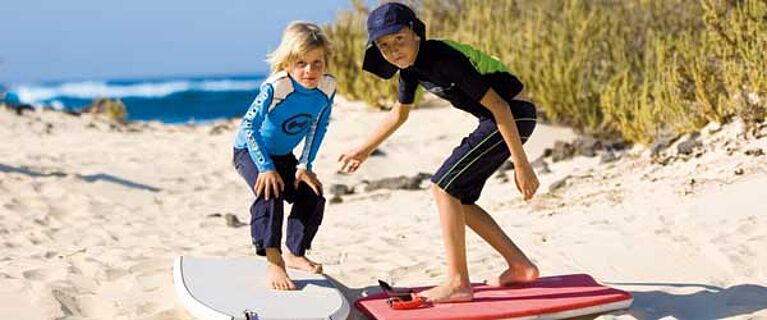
[0,99,767,319]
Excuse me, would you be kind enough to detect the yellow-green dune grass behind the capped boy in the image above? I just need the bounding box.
[325,0,767,143]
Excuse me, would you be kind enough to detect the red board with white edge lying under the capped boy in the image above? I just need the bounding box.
[354,274,633,320]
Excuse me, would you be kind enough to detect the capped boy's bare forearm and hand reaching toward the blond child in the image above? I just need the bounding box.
[338,102,413,173]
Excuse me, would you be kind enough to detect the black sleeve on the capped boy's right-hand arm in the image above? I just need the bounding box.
[437,52,490,102]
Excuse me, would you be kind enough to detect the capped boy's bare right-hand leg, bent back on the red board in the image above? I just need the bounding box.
[463,204,538,285]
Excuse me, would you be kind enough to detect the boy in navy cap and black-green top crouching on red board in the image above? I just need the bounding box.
[339,3,539,303]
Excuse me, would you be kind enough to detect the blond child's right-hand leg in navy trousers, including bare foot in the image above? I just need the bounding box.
[283,183,325,273]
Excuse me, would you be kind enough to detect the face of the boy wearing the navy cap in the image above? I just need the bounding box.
[375,27,421,69]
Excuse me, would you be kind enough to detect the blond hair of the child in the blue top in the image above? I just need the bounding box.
[266,21,333,73]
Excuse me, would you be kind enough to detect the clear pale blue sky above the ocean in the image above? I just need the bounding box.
[0,0,351,84]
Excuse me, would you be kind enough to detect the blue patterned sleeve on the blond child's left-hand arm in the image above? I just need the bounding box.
[242,83,274,172]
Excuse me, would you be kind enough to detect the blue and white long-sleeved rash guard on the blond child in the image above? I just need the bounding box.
[234,72,336,172]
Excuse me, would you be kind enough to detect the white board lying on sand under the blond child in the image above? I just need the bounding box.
[173,256,350,320]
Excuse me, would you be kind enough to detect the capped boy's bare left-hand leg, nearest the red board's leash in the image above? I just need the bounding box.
[420,185,474,303]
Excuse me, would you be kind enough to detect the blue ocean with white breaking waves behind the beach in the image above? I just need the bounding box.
[12,75,266,124]
